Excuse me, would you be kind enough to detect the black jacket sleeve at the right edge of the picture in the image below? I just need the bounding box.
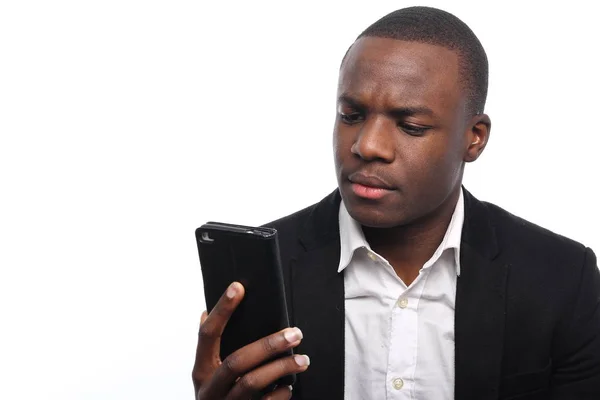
[551,248,600,400]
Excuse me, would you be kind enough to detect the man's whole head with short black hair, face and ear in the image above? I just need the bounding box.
[334,7,490,228]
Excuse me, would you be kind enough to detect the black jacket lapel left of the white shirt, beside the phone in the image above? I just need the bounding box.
[291,190,345,400]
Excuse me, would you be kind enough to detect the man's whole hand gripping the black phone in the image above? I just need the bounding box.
[192,282,310,400]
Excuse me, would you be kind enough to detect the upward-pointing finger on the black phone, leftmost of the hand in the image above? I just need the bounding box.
[194,282,244,379]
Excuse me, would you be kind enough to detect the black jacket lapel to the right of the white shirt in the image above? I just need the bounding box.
[455,190,508,400]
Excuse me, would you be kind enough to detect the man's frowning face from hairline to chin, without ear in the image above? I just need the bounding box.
[334,37,472,228]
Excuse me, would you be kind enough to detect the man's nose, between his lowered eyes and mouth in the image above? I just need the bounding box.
[351,117,396,163]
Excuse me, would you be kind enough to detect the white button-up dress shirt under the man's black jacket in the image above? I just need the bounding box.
[338,190,464,400]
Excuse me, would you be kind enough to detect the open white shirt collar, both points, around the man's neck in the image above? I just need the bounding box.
[338,189,465,276]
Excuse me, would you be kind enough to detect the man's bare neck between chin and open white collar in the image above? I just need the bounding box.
[362,185,462,286]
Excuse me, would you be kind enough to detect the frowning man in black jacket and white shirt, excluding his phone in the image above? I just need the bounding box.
[193,7,600,400]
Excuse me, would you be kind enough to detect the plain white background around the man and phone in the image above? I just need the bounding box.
[0,0,600,400]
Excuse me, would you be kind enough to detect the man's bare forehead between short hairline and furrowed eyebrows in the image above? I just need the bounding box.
[338,37,463,106]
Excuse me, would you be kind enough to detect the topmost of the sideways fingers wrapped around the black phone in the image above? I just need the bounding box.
[210,328,302,397]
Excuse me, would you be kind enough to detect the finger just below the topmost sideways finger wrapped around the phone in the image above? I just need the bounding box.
[226,354,310,400]
